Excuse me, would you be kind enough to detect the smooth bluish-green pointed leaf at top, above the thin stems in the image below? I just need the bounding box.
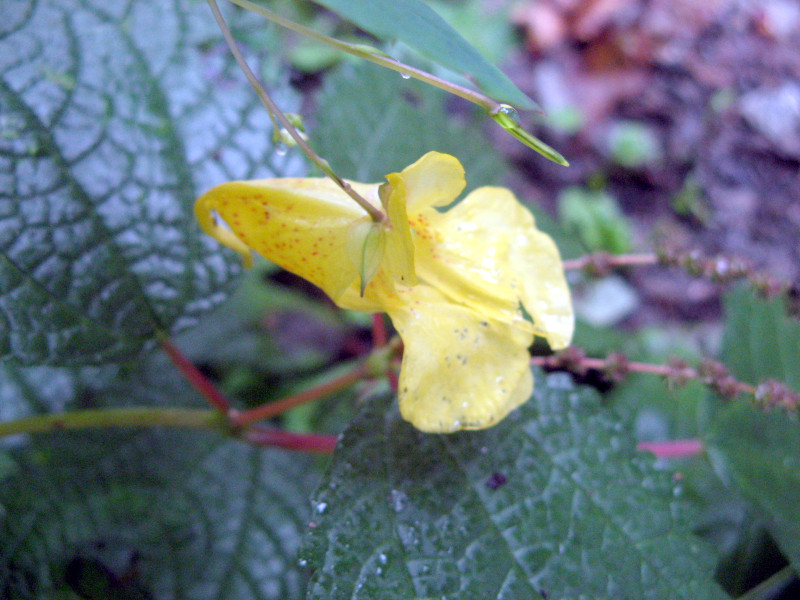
[306,0,537,109]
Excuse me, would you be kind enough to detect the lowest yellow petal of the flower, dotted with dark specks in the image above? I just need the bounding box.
[389,284,533,433]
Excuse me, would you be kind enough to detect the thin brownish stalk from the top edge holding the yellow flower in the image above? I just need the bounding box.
[208,0,386,223]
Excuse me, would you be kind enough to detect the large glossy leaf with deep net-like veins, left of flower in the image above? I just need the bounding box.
[0,0,304,364]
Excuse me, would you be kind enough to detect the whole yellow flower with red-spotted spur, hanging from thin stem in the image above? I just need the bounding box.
[195,152,573,433]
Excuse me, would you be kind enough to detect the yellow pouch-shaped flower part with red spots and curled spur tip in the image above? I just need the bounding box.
[195,179,377,301]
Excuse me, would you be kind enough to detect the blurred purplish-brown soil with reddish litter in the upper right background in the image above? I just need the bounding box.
[506,0,800,321]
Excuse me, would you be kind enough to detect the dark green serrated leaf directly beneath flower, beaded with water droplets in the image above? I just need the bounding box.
[300,375,725,600]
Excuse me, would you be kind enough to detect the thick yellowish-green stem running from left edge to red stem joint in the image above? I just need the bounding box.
[0,406,229,437]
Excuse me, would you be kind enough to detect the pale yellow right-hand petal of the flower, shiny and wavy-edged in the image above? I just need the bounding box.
[412,187,574,349]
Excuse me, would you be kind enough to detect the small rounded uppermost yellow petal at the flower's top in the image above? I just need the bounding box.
[400,152,466,215]
